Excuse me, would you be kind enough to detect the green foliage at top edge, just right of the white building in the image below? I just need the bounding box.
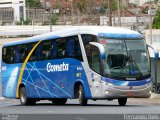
[26,0,42,8]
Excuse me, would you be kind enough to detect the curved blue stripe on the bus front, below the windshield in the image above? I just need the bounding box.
[101,77,151,86]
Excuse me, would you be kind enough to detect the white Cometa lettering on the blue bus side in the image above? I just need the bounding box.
[46,62,69,72]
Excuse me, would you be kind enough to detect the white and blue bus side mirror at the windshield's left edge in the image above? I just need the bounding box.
[89,42,106,59]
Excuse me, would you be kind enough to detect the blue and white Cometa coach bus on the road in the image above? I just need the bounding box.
[2,26,152,106]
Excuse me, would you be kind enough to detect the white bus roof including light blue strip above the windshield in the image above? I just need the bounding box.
[4,26,143,46]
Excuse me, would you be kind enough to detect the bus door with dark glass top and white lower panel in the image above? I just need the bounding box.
[86,45,102,98]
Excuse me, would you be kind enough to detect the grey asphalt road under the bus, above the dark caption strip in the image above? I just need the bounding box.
[0,100,160,114]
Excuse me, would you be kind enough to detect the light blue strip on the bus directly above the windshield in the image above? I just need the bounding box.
[98,33,143,39]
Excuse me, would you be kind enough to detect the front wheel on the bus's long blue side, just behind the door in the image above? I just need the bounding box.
[78,85,87,106]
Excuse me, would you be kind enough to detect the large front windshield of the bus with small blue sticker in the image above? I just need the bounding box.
[100,38,150,80]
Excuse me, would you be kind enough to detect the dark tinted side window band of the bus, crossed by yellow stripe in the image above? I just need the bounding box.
[3,36,83,64]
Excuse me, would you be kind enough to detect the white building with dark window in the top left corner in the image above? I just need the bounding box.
[0,0,26,21]
